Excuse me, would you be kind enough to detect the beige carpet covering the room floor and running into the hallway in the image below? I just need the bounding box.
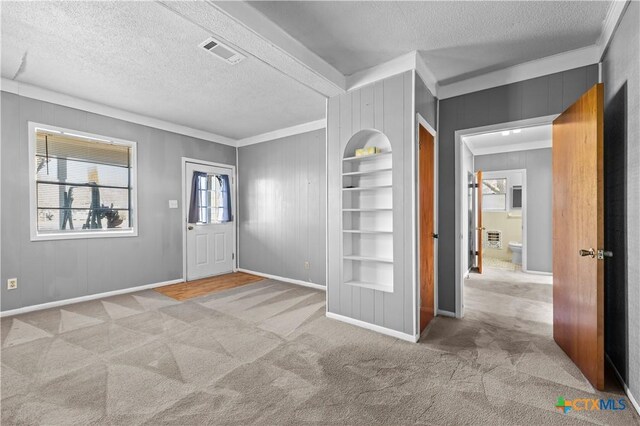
[1,274,638,425]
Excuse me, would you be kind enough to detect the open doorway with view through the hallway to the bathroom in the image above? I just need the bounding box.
[456,117,554,324]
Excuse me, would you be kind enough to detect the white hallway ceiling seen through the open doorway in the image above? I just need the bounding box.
[463,124,551,155]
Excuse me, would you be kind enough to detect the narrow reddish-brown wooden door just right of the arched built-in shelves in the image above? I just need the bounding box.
[418,126,436,333]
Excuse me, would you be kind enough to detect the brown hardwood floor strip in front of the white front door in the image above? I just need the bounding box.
[155,272,264,301]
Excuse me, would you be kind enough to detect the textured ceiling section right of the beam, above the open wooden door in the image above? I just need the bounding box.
[250,1,610,84]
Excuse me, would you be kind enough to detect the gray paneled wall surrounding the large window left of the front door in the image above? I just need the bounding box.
[0,92,236,311]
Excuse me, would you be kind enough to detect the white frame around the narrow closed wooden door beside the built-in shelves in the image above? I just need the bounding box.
[414,113,439,334]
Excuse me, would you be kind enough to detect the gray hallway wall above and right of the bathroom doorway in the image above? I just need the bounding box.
[474,148,553,272]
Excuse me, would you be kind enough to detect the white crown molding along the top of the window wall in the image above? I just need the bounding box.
[0,78,237,147]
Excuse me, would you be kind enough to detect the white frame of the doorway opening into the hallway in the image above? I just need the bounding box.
[454,114,559,318]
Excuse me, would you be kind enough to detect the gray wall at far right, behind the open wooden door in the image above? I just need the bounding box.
[602,2,640,406]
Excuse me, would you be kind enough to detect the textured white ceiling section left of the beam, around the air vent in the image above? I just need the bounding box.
[2,1,325,139]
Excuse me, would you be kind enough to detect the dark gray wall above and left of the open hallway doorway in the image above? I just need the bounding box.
[438,64,598,312]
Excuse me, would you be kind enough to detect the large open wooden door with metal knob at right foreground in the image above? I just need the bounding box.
[553,84,604,390]
